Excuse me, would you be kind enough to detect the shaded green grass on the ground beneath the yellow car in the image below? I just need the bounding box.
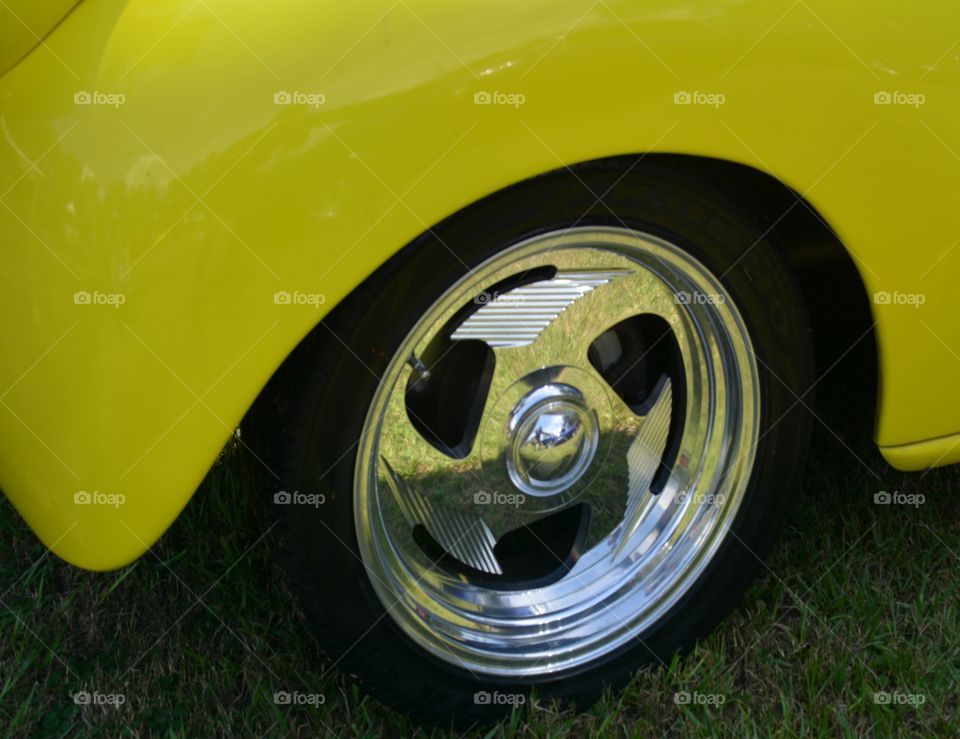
[0,348,960,737]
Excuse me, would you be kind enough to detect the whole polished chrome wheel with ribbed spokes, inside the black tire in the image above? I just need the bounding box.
[354,227,760,678]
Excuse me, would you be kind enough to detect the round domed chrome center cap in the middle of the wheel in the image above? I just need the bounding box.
[507,383,599,497]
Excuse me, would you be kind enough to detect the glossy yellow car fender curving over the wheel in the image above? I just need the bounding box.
[0,0,960,569]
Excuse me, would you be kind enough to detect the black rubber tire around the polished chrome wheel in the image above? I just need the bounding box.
[246,157,813,727]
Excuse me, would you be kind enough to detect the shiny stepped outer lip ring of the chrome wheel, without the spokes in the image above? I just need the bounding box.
[354,226,760,678]
